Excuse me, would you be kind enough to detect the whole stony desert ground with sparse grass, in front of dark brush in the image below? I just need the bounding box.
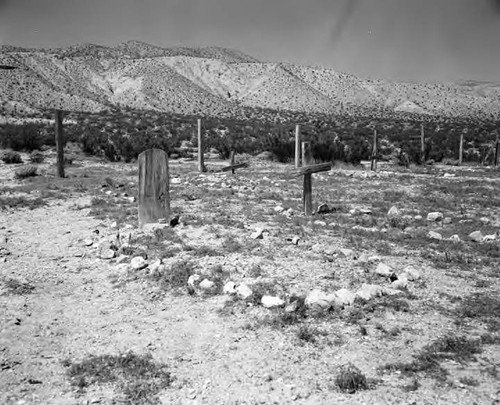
[0,150,500,405]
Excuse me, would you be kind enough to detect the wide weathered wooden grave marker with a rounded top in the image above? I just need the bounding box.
[138,149,170,228]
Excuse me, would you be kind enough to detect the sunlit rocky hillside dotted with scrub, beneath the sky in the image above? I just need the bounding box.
[0,41,500,118]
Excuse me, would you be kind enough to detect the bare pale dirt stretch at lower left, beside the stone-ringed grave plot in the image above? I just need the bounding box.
[0,196,496,405]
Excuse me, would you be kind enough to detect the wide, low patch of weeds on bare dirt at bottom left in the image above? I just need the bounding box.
[63,352,173,405]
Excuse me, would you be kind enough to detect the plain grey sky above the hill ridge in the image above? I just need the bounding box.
[0,0,500,82]
